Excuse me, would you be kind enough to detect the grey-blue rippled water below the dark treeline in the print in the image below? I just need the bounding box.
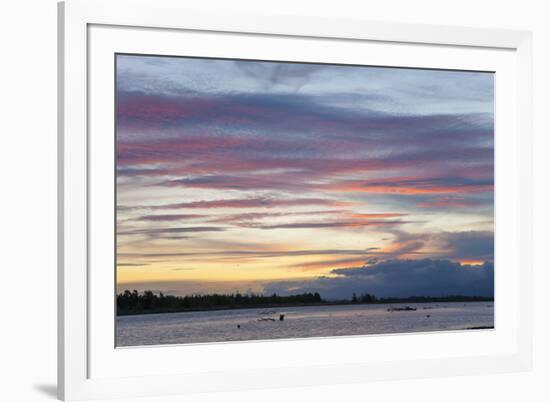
[116,302,494,346]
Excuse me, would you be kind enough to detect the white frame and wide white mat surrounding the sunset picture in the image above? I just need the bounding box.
[58,0,532,400]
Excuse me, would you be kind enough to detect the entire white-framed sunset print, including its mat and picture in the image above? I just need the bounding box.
[59,0,531,400]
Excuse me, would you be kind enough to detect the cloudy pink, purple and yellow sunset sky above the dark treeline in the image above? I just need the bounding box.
[116,55,494,299]
